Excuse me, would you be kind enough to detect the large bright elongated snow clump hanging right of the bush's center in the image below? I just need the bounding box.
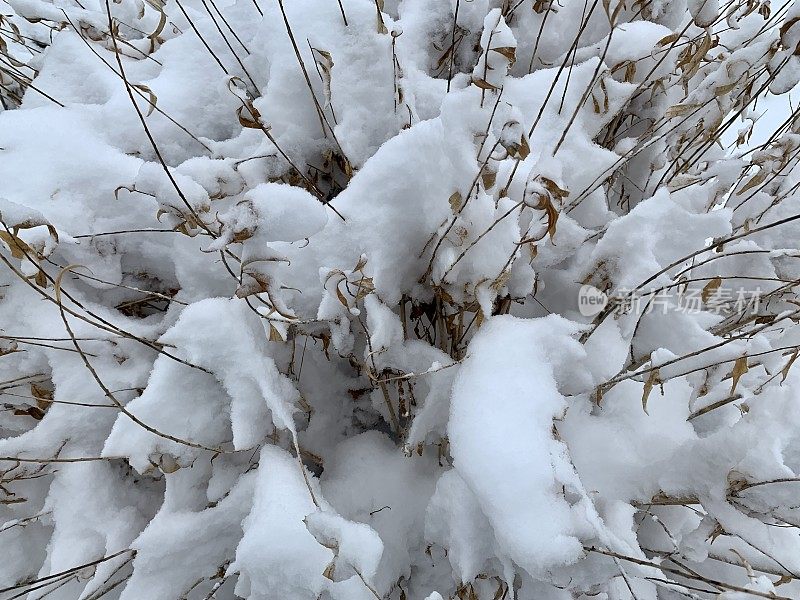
[448,317,582,576]
